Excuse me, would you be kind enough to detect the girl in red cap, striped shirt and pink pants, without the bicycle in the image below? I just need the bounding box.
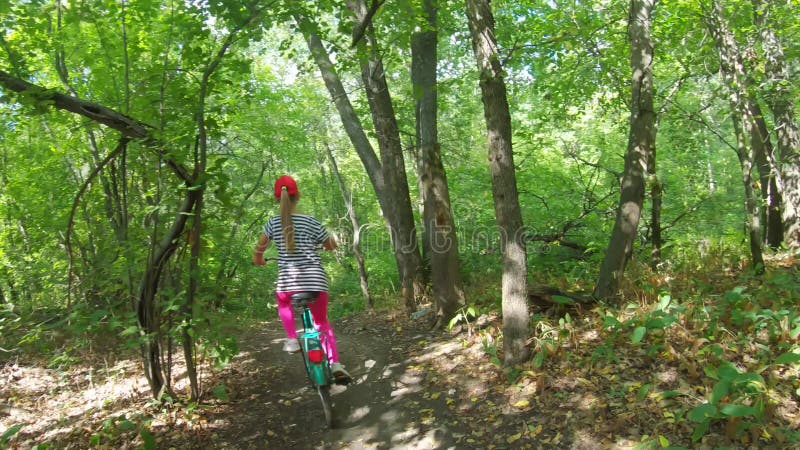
[253,175,350,380]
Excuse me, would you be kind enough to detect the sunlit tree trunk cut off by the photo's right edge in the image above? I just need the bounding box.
[753,0,800,250]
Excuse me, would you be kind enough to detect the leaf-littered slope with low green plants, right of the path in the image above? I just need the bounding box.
[466,251,800,448]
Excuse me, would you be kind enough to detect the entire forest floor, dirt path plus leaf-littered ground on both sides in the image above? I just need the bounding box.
[0,260,800,450]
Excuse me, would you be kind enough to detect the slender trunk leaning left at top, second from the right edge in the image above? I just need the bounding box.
[705,0,764,272]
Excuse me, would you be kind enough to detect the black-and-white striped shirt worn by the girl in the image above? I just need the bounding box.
[264,214,328,292]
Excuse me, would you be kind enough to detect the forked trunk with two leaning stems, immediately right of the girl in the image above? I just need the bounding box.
[295,15,422,311]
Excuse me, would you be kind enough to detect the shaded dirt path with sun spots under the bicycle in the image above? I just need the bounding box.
[171,310,463,450]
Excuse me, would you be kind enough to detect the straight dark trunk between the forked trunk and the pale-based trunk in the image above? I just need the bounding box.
[411,0,465,326]
